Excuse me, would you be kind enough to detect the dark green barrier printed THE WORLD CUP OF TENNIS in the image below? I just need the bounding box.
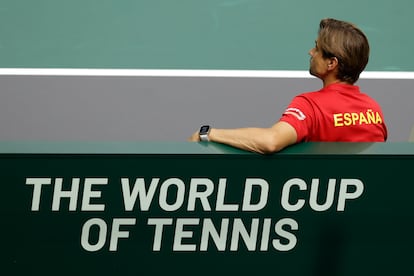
[0,142,414,275]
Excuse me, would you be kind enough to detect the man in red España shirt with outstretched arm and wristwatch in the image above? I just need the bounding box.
[189,18,387,154]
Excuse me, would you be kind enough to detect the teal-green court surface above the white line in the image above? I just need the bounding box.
[0,0,414,71]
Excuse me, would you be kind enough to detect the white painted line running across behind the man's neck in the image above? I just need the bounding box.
[0,68,414,79]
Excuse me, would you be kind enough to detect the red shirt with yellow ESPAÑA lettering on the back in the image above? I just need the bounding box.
[280,83,387,142]
